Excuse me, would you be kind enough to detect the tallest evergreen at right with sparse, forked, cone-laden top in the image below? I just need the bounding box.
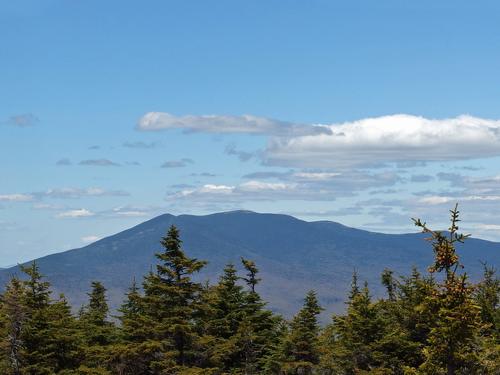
[415,206,482,375]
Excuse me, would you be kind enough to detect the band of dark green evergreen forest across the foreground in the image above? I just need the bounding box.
[0,207,500,375]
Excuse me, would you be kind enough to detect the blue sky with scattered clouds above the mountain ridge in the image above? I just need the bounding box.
[0,0,500,266]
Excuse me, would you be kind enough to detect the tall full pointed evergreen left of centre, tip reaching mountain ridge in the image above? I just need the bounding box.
[143,226,206,373]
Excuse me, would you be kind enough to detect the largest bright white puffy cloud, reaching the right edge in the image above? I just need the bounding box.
[264,114,500,168]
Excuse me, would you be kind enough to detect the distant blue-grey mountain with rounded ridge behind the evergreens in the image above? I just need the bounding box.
[0,211,500,316]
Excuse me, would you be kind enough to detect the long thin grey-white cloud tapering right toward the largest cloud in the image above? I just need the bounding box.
[137,112,330,135]
